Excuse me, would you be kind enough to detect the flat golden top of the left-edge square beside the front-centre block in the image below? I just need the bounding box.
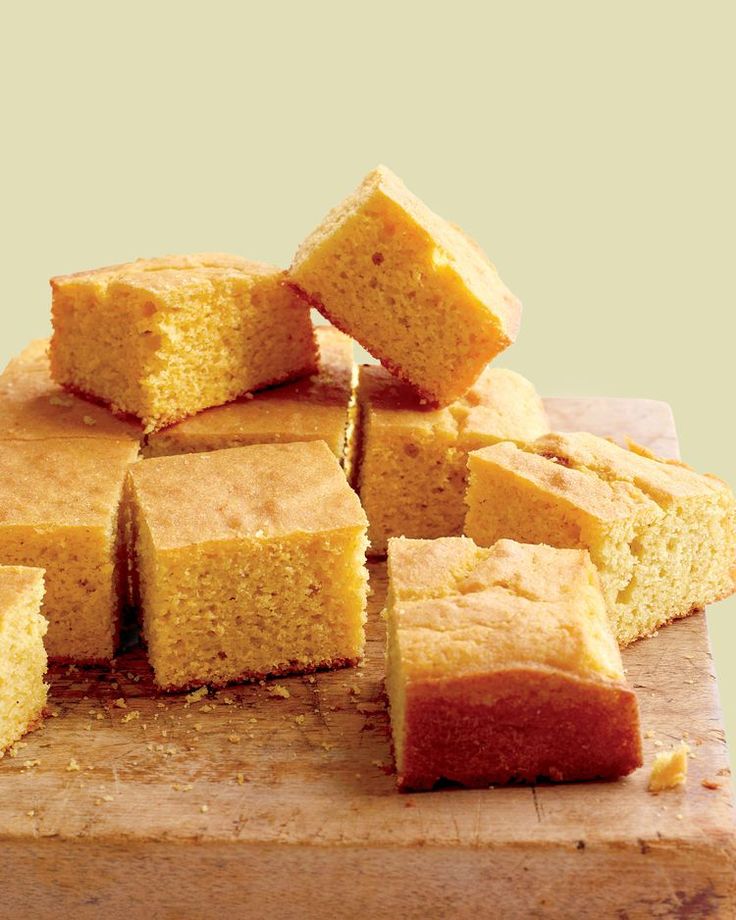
[0,438,138,528]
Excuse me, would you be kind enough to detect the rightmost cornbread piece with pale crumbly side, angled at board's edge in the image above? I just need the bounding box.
[465,433,736,645]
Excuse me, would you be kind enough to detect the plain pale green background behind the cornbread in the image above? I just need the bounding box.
[0,0,736,760]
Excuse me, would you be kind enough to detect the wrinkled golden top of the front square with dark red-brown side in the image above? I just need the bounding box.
[388,537,624,683]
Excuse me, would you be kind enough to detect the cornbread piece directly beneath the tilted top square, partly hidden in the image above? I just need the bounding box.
[353,365,549,555]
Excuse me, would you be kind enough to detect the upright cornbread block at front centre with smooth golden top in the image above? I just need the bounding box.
[128,441,367,690]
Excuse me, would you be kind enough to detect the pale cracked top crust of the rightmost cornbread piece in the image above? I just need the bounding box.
[470,432,729,522]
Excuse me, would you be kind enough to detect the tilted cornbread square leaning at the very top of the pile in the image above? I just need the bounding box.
[290,166,521,405]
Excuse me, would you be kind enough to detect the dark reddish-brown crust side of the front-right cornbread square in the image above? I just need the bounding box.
[398,668,642,790]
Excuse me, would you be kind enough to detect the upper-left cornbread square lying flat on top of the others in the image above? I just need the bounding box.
[51,253,317,431]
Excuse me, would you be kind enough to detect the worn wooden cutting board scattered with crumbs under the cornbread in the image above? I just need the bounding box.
[0,399,736,920]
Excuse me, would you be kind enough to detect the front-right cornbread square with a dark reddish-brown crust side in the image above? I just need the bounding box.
[386,537,641,789]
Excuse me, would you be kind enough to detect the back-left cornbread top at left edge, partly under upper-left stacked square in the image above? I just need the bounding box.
[0,339,143,443]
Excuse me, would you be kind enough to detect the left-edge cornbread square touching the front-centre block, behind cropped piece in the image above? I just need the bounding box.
[0,438,138,663]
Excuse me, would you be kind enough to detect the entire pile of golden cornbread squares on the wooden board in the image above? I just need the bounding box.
[0,167,736,789]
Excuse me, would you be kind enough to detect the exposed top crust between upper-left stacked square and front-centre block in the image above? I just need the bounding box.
[146,326,353,456]
